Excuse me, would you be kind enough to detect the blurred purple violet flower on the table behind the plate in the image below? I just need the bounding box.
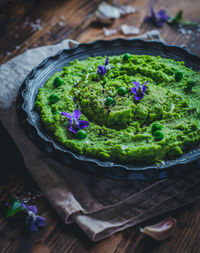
[144,6,169,27]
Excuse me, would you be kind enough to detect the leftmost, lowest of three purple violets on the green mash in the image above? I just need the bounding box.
[61,109,90,134]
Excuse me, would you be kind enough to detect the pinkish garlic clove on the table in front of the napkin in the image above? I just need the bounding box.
[140,217,177,241]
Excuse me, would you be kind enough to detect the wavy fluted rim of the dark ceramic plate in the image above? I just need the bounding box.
[16,38,200,179]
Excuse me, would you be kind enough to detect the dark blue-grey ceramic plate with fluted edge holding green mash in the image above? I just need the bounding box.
[17,39,200,180]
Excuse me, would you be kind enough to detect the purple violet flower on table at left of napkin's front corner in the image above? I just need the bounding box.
[21,203,46,232]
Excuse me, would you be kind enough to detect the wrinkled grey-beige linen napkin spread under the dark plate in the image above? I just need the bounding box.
[0,35,200,241]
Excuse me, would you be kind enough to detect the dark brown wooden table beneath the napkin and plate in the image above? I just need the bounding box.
[0,0,200,253]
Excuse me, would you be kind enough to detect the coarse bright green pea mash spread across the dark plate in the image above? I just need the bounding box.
[35,55,200,163]
